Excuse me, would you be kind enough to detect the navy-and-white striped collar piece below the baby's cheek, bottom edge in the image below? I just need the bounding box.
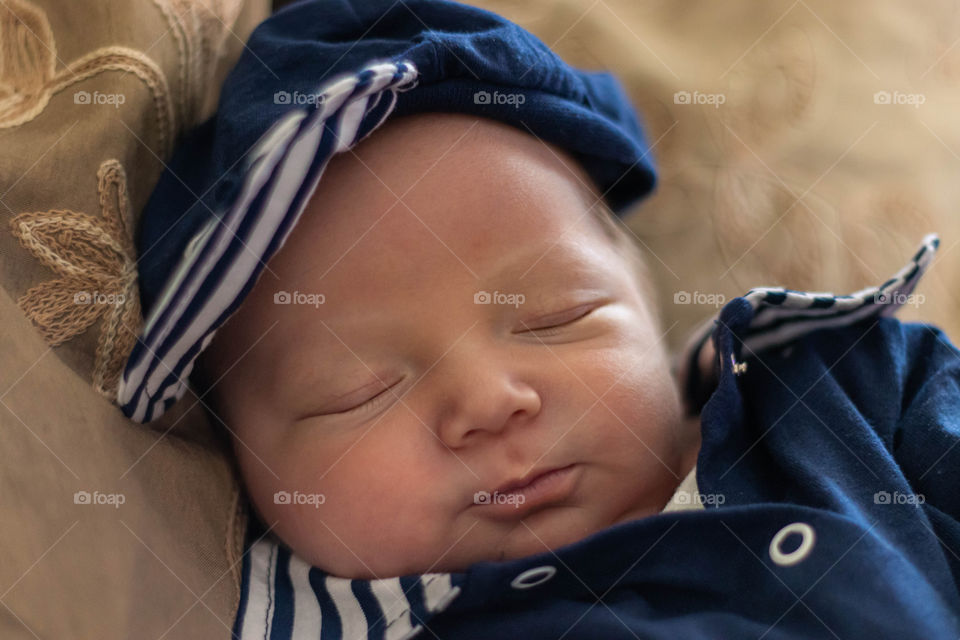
[233,537,464,640]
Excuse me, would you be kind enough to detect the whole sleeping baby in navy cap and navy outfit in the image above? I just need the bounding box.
[119,0,960,639]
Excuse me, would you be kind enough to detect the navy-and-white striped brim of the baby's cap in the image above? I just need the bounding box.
[117,62,418,422]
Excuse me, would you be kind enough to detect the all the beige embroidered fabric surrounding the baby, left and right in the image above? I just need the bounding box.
[0,0,960,638]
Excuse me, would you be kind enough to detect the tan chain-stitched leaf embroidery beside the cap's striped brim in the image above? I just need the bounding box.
[10,160,143,400]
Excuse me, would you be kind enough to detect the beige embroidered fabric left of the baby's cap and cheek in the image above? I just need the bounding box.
[0,0,268,639]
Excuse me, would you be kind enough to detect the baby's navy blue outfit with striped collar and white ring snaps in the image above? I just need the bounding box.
[235,236,960,640]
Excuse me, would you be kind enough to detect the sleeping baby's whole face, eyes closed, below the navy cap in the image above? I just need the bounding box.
[204,115,699,578]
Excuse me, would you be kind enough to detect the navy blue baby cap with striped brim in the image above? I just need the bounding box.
[118,0,656,422]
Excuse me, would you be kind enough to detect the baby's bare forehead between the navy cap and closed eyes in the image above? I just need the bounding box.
[202,117,625,370]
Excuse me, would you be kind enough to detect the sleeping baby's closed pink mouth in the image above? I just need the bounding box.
[473,463,581,519]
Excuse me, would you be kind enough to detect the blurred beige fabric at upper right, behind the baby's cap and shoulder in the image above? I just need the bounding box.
[471,0,960,347]
